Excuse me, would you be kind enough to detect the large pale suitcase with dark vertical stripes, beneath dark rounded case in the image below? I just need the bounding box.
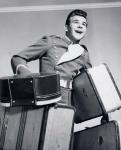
[0,105,74,150]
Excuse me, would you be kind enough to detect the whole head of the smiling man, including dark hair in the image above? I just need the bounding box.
[65,10,87,43]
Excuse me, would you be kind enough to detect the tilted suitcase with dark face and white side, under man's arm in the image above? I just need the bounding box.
[72,64,121,123]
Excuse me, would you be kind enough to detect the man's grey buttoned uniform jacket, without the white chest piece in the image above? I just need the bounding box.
[11,35,91,80]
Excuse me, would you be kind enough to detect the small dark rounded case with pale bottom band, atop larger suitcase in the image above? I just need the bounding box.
[0,73,61,107]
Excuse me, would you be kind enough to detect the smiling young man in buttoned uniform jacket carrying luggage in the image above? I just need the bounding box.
[11,9,91,105]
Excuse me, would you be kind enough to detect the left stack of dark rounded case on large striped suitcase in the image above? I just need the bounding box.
[0,74,75,150]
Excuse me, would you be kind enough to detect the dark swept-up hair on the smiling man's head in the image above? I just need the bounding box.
[65,9,87,25]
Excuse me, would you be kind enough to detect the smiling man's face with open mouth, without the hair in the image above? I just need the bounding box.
[67,15,87,42]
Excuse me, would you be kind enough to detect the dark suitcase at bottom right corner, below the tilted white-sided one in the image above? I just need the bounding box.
[73,120,121,150]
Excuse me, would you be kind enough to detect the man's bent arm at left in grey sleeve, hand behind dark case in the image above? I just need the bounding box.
[11,36,52,74]
